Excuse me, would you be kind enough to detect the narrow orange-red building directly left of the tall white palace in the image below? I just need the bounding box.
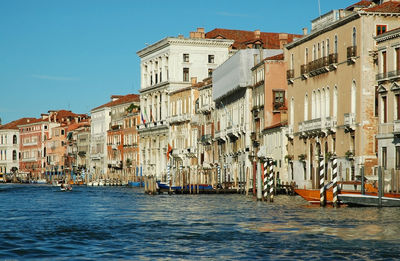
[122,105,141,180]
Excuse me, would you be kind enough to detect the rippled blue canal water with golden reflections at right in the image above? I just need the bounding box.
[0,184,400,260]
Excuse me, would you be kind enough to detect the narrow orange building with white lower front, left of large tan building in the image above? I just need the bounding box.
[251,52,289,182]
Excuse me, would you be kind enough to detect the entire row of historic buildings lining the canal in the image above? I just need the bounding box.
[0,0,400,188]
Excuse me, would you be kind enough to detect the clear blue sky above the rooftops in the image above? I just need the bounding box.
[0,0,357,124]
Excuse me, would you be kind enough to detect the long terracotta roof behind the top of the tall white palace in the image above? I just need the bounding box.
[206,28,302,49]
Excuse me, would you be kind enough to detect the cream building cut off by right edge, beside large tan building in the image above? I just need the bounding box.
[375,27,400,170]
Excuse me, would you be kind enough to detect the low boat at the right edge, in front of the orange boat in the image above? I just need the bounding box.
[338,194,400,207]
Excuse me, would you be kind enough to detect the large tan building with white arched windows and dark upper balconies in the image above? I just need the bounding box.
[285,1,400,188]
